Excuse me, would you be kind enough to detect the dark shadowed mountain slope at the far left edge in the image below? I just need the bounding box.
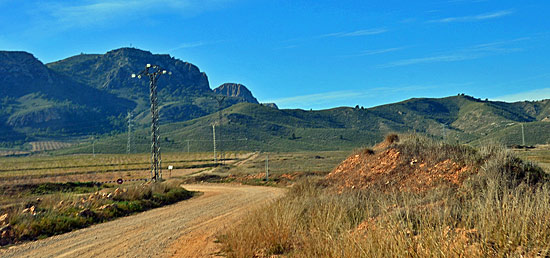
[0,51,135,144]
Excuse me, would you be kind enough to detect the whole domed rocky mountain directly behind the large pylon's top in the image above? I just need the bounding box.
[47,48,264,124]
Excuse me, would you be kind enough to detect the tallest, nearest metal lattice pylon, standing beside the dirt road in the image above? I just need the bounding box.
[132,64,172,182]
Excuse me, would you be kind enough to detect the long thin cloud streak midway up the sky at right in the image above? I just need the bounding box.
[378,37,530,68]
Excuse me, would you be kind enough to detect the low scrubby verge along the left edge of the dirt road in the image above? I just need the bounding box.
[0,180,193,245]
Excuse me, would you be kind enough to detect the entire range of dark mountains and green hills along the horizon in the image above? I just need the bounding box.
[4,48,550,153]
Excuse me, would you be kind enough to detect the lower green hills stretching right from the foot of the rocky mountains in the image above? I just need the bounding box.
[57,95,550,153]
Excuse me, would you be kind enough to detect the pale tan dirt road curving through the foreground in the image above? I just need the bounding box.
[0,184,284,257]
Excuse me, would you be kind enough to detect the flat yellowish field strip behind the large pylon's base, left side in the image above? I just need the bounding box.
[0,153,246,185]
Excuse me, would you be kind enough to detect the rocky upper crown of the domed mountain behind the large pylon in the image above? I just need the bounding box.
[48,48,211,100]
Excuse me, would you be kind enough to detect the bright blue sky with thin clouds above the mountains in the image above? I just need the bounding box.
[0,0,550,109]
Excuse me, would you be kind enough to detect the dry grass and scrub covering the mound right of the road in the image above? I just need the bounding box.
[220,135,550,257]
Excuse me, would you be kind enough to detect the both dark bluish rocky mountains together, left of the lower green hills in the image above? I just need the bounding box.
[0,48,264,147]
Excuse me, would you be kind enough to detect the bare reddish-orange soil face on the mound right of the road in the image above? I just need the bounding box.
[327,145,473,192]
